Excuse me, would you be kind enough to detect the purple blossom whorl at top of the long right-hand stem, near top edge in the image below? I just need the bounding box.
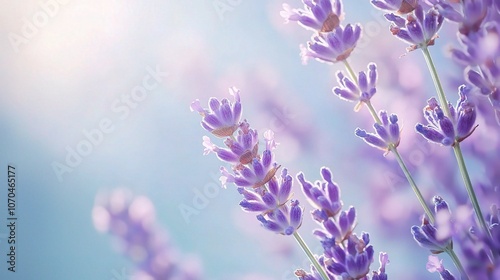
[385,5,444,52]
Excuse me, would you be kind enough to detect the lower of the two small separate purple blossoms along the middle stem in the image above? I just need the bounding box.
[355,111,400,154]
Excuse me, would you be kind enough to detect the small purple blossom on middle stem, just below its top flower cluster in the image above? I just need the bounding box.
[332,63,377,111]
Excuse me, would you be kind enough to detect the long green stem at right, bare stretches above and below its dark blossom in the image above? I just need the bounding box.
[422,47,491,242]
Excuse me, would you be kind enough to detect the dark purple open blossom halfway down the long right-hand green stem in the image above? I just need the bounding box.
[415,86,476,146]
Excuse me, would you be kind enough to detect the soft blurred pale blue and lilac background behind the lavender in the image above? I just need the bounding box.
[0,0,498,280]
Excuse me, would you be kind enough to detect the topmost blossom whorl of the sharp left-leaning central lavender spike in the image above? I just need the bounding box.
[191,87,241,137]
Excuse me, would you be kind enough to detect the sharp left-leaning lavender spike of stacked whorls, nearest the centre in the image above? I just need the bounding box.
[191,87,303,235]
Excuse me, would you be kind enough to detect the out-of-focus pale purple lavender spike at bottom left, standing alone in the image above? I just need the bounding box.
[92,189,201,280]
